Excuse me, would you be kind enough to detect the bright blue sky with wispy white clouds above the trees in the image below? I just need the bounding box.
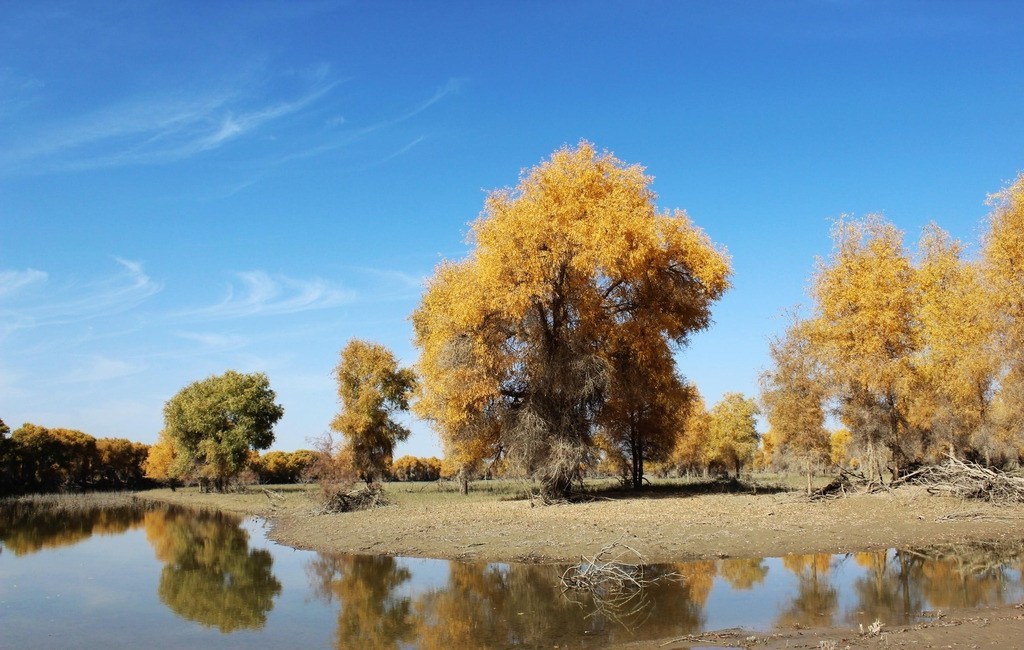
[0,0,1024,454]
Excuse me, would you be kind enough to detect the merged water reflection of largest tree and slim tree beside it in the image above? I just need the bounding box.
[307,556,707,650]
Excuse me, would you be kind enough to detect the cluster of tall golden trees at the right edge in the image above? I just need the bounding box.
[762,174,1024,487]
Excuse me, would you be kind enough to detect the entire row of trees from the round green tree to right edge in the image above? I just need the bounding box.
[4,142,1024,500]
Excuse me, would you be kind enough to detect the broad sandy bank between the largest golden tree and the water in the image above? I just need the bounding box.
[260,489,1024,562]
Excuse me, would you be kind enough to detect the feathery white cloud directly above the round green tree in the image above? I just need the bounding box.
[180,271,355,319]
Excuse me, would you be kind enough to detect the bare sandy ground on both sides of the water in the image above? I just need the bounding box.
[140,488,1024,650]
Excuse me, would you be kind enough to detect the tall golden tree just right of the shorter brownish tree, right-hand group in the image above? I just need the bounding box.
[808,215,921,476]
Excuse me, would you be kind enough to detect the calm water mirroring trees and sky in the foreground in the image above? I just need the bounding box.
[0,507,1024,650]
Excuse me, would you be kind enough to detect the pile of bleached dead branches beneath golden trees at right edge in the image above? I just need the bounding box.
[900,457,1024,504]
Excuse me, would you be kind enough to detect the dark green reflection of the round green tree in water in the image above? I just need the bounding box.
[143,508,281,633]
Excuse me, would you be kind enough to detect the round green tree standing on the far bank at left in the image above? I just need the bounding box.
[162,371,285,491]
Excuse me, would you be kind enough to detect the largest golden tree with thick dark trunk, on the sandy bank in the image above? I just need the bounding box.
[413,142,729,495]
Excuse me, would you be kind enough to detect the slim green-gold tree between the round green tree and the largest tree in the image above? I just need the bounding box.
[331,339,416,483]
